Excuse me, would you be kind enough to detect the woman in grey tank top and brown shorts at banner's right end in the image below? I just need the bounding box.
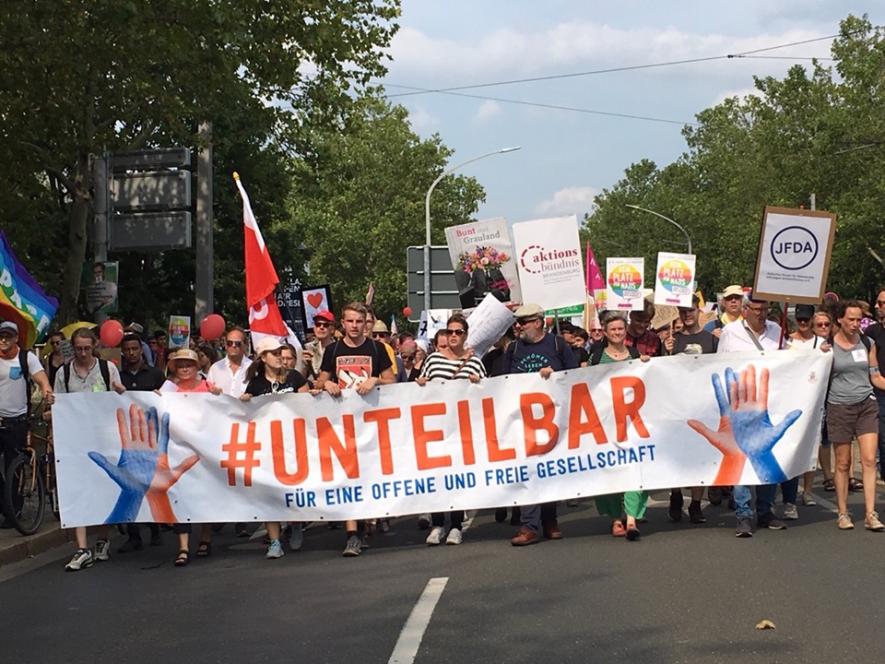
[827,300,885,532]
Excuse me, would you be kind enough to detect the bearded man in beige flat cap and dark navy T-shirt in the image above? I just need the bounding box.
[504,304,578,546]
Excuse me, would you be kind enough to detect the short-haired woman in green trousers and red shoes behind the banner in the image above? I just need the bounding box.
[590,311,651,542]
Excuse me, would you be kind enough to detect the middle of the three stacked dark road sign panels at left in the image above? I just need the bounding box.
[111,171,191,210]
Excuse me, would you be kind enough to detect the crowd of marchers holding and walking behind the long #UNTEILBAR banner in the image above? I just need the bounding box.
[0,285,885,571]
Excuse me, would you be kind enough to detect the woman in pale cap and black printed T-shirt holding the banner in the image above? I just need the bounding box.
[240,337,308,560]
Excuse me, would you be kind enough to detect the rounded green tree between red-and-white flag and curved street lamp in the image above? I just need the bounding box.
[288,96,485,317]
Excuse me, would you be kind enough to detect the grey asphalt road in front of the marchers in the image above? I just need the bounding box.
[0,482,885,664]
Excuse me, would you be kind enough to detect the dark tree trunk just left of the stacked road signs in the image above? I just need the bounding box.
[56,154,92,325]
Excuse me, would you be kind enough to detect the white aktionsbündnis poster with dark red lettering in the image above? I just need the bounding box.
[513,215,586,309]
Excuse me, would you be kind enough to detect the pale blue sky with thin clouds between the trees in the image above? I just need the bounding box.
[382,0,885,223]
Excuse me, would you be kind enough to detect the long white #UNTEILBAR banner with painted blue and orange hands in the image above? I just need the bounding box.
[53,351,832,528]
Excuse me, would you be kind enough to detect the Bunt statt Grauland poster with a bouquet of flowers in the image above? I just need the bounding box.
[446,217,522,309]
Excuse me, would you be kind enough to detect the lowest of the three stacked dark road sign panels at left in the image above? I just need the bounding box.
[108,212,191,251]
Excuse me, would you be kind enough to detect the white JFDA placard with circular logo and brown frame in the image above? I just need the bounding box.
[753,207,836,304]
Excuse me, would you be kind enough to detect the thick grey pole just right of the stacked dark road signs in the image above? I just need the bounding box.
[194,122,215,325]
